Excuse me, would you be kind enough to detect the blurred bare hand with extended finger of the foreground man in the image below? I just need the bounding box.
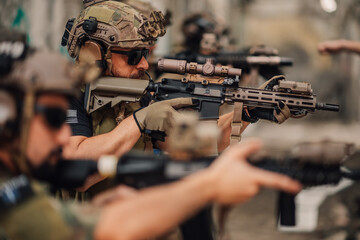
[209,140,301,204]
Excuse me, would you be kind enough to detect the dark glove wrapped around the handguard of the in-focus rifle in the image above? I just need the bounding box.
[243,75,306,124]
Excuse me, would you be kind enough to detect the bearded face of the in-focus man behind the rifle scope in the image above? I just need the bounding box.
[111,48,149,78]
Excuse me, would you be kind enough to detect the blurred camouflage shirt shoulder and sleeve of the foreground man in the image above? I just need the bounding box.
[0,167,99,240]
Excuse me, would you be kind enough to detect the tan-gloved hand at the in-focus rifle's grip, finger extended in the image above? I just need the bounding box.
[134,98,193,133]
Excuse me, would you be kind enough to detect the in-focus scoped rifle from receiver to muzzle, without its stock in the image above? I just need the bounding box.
[147,59,339,120]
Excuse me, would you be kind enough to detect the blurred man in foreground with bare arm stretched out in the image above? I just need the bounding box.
[0,28,300,240]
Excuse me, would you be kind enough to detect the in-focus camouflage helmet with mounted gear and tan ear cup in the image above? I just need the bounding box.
[62,0,166,74]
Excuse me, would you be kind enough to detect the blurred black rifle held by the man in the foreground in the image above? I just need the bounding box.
[46,142,360,229]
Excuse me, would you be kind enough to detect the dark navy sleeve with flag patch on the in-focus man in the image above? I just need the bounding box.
[66,95,93,137]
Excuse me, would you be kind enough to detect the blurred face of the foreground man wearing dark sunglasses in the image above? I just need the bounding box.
[27,94,71,168]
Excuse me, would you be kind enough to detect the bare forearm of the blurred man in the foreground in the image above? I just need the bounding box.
[95,170,214,240]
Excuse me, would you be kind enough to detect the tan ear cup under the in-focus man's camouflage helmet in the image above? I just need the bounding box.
[77,41,107,72]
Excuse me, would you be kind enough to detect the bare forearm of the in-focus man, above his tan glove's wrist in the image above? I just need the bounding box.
[64,116,141,159]
